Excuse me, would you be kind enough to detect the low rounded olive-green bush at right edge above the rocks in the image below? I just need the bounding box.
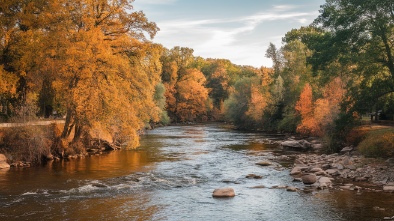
[358,129,394,158]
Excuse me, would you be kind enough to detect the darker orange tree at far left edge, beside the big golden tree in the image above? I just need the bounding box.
[0,0,49,120]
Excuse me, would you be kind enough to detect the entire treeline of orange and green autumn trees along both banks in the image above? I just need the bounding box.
[0,0,394,154]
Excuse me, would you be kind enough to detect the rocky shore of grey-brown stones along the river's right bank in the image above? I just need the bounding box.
[290,149,394,192]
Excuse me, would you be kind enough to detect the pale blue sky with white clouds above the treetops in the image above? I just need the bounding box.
[133,0,325,67]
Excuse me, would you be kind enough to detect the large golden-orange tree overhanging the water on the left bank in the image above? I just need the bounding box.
[45,0,161,148]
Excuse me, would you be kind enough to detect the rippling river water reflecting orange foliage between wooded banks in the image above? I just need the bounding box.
[0,124,394,221]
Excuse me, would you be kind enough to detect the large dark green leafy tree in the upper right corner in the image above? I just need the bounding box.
[314,0,394,112]
